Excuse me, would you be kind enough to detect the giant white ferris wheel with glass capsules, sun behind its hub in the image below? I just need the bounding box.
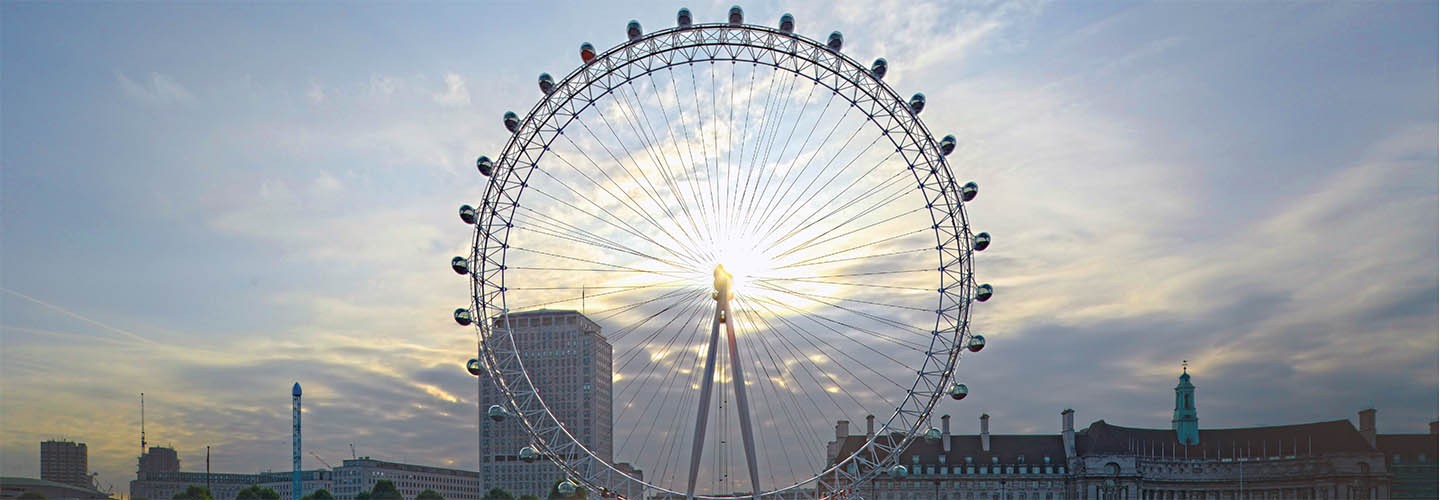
[451,7,994,499]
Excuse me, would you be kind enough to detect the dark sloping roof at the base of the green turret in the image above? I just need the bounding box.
[1076,419,1375,457]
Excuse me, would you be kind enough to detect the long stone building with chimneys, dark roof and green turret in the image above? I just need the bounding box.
[827,373,1416,500]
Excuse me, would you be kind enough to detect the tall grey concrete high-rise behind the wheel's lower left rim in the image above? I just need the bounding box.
[480,310,613,497]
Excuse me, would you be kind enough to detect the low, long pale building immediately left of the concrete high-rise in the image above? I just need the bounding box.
[329,457,475,500]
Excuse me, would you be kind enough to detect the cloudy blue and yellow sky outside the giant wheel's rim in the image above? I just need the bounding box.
[0,1,1440,493]
